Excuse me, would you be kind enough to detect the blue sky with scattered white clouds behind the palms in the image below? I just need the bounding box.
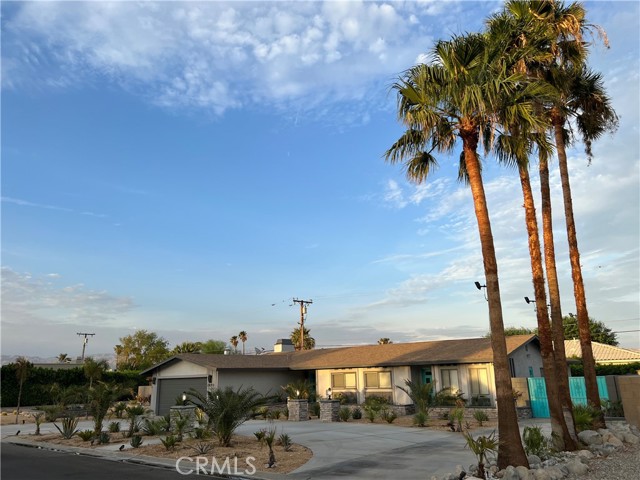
[1,1,640,357]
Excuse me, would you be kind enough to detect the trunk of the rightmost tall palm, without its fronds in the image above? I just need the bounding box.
[552,112,605,428]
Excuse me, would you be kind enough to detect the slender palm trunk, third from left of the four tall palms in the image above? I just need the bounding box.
[539,155,578,442]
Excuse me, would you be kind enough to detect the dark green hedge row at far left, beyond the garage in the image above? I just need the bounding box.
[0,363,148,408]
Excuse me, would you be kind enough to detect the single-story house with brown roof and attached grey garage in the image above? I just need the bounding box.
[142,335,543,415]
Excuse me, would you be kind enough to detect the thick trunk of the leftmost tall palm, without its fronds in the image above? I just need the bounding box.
[463,132,529,469]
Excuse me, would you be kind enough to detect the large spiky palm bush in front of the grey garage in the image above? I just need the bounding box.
[190,387,267,447]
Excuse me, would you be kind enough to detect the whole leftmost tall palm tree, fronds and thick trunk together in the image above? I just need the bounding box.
[385,35,539,468]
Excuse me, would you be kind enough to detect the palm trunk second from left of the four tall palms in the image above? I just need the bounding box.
[519,166,575,451]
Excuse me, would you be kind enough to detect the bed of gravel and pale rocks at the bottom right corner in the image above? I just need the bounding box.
[431,422,640,480]
